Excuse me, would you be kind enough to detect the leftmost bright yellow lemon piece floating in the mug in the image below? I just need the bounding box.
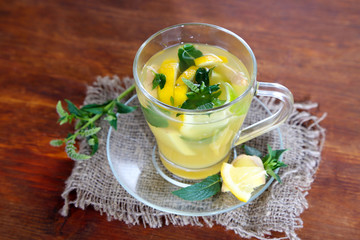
[158,59,179,105]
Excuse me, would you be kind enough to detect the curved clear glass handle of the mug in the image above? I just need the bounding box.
[234,82,294,146]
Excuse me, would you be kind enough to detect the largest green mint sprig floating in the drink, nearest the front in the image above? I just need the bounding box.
[181,79,225,109]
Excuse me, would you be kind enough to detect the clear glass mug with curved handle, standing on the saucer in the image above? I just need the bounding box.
[133,23,293,179]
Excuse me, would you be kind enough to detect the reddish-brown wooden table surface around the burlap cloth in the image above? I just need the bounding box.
[0,0,360,240]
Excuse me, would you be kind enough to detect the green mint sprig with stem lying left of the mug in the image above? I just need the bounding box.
[50,85,136,160]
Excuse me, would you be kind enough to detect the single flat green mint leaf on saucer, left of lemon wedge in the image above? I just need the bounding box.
[172,174,221,201]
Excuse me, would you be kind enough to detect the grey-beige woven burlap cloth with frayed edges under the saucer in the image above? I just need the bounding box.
[60,76,325,239]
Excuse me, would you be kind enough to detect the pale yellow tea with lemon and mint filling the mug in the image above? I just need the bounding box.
[139,44,253,179]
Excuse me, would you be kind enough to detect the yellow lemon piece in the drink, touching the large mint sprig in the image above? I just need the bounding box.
[174,66,198,107]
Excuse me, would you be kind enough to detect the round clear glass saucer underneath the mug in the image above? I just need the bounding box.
[106,95,284,216]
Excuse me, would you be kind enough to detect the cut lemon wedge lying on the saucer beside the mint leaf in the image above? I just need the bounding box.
[221,163,265,202]
